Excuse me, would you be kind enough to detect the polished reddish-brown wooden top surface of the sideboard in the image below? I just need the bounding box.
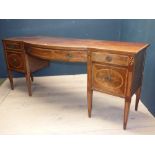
[4,36,149,53]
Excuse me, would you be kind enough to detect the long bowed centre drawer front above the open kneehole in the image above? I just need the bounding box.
[26,47,87,62]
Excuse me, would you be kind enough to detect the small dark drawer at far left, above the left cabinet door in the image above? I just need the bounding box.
[4,41,24,51]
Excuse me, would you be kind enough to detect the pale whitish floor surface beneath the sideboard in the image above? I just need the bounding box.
[0,75,155,135]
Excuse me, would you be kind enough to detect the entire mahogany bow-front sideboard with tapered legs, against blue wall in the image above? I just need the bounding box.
[3,36,149,129]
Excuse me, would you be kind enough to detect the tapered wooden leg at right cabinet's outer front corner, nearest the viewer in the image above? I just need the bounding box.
[123,98,131,130]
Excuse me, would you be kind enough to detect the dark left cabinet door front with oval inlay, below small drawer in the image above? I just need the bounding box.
[6,52,25,71]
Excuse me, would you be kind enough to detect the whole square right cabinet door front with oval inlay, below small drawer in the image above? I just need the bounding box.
[92,64,127,97]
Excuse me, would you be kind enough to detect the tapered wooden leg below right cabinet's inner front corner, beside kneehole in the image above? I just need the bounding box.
[87,90,93,117]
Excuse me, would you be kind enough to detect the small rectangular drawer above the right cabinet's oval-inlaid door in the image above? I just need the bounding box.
[92,52,129,66]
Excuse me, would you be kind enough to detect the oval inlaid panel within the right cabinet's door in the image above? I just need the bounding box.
[95,69,123,89]
